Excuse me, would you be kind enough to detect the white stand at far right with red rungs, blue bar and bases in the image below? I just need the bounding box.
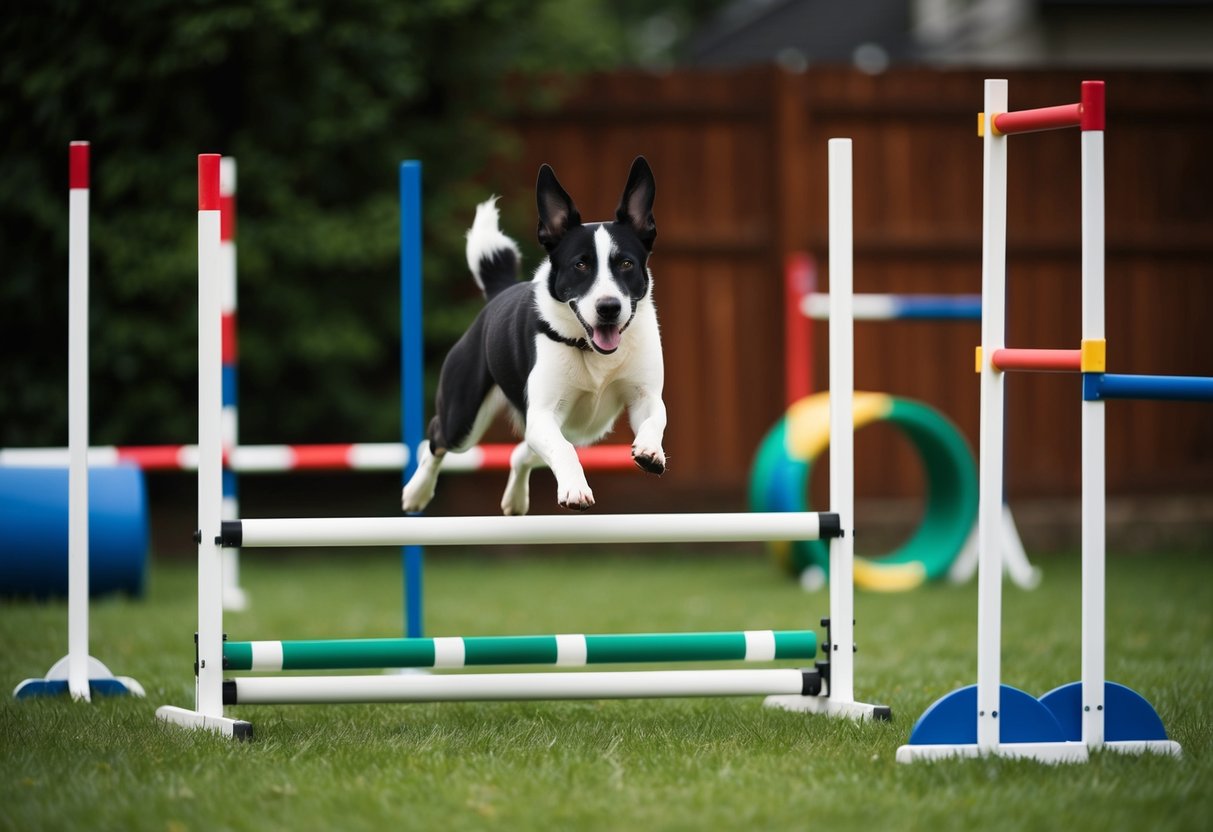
[898,80,1188,763]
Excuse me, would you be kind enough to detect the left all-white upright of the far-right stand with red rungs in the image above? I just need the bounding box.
[974,80,1007,751]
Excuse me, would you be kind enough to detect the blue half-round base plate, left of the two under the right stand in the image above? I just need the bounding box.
[910,685,1066,746]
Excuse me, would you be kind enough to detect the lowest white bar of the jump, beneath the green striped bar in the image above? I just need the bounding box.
[228,668,804,705]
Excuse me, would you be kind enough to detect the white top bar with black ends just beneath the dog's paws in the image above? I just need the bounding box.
[217,512,842,548]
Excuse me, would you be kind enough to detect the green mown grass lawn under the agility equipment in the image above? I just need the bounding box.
[0,549,1213,831]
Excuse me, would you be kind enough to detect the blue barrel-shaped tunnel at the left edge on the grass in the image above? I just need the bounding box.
[0,466,148,598]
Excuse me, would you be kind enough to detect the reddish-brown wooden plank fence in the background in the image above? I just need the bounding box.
[451,68,1213,511]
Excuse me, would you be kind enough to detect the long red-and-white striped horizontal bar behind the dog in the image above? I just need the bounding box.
[0,441,636,474]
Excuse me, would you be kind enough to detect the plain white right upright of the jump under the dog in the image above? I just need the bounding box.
[830,138,855,702]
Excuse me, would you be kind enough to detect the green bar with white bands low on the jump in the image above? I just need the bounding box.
[223,629,818,672]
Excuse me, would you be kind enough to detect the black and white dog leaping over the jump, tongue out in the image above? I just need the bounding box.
[400,156,666,514]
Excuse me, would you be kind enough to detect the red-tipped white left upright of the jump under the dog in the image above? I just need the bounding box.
[197,153,223,717]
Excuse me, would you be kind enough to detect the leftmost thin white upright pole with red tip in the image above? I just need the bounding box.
[68,142,90,701]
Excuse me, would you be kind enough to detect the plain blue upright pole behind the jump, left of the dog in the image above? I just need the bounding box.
[400,160,426,638]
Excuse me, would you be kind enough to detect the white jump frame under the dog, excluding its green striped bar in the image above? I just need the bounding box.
[156,139,890,737]
